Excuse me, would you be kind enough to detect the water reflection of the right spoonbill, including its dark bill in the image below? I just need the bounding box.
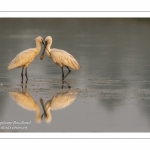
[40,91,78,123]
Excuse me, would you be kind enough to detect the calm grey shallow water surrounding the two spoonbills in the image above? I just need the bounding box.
[0,18,150,132]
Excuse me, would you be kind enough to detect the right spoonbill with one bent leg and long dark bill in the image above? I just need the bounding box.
[40,36,80,80]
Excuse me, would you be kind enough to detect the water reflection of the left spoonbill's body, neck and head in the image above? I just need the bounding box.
[9,89,42,123]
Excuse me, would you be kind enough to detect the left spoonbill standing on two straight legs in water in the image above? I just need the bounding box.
[8,36,44,83]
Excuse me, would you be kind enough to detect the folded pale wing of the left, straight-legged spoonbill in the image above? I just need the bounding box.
[8,49,35,69]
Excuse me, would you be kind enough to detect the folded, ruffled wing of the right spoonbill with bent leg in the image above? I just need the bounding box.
[51,50,80,70]
